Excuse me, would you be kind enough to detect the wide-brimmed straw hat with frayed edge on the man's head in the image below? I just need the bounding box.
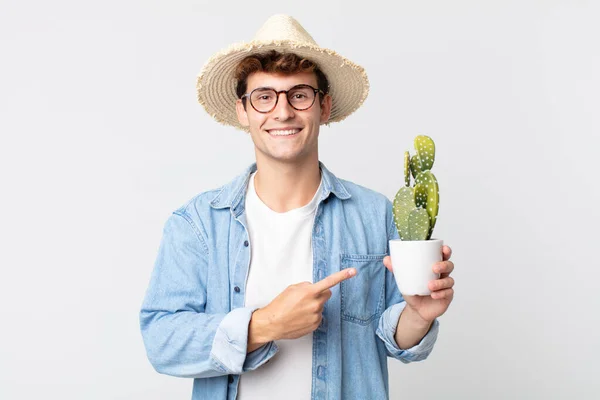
[196,14,369,131]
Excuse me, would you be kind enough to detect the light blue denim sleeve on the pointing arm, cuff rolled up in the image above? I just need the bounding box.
[139,210,277,378]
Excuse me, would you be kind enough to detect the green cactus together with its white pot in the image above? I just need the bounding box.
[389,135,444,296]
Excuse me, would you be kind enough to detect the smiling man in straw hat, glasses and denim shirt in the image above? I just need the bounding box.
[140,15,454,400]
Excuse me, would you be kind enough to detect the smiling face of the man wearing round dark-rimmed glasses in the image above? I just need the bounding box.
[236,71,331,163]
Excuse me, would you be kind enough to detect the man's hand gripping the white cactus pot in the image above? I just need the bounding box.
[383,246,454,323]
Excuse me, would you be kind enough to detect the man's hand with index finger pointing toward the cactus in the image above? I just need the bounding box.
[248,268,356,352]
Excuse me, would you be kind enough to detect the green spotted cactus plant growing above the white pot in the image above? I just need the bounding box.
[393,135,440,240]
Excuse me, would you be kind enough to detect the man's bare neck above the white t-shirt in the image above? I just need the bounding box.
[254,157,321,213]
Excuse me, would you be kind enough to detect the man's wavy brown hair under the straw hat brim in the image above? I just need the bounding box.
[235,50,329,108]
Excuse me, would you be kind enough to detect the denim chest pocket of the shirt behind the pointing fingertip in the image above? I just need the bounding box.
[340,253,386,325]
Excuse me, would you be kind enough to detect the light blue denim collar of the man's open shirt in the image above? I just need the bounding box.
[210,161,351,210]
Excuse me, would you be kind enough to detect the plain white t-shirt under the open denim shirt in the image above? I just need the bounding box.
[237,172,322,400]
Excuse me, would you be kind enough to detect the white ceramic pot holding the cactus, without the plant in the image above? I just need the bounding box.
[390,239,444,296]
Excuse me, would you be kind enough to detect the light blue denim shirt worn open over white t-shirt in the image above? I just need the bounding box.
[139,162,439,400]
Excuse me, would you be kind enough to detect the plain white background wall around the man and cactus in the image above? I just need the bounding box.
[0,0,600,400]
